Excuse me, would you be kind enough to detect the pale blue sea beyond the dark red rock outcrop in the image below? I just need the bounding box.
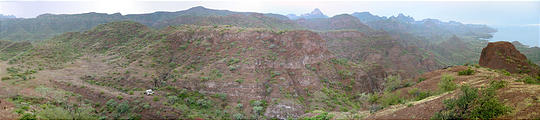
[489,25,540,47]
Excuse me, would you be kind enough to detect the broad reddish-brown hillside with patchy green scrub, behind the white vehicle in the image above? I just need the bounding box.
[0,21,387,119]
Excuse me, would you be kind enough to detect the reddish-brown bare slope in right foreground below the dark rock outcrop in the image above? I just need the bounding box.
[365,66,540,119]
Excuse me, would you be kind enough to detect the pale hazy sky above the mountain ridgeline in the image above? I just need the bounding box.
[0,0,540,46]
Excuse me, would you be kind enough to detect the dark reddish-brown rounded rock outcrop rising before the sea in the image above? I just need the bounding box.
[480,42,538,73]
